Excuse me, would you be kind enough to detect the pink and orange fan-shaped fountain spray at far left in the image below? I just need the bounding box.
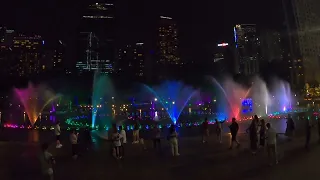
[14,83,60,126]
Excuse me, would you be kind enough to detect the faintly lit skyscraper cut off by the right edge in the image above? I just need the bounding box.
[283,0,320,84]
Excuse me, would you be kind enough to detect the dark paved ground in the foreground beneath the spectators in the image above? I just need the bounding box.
[0,127,320,180]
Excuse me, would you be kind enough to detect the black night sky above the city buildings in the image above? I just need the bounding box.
[0,0,283,63]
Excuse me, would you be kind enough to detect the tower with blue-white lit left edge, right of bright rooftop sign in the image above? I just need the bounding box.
[234,24,260,76]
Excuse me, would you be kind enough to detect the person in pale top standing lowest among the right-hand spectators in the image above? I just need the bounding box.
[266,123,278,165]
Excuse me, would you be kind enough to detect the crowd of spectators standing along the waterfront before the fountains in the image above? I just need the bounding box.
[40,112,320,179]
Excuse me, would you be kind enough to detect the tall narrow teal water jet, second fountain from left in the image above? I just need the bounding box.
[91,72,114,128]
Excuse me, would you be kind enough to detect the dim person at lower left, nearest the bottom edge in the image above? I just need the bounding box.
[39,143,55,180]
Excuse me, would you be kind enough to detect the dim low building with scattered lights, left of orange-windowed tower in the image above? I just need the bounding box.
[117,42,145,77]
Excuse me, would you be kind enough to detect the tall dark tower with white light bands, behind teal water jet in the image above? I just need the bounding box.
[76,3,115,73]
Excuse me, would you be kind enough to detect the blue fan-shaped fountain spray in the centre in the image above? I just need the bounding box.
[145,81,197,124]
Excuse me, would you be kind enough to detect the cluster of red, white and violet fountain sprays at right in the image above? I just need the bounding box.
[210,77,292,119]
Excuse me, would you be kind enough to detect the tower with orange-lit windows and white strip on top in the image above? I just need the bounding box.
[157,16,183,65]
